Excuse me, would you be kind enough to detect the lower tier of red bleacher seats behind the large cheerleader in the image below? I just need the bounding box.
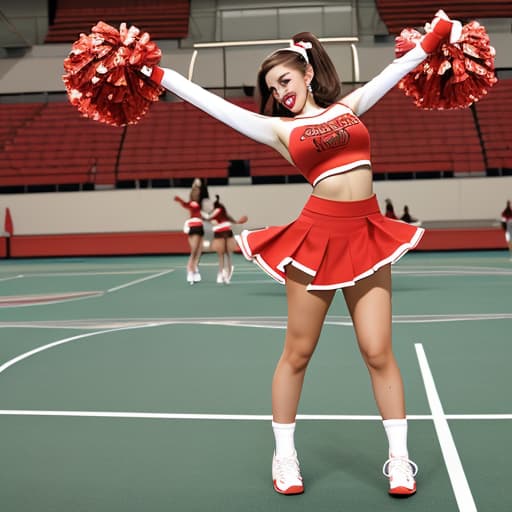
[0,79,512,187]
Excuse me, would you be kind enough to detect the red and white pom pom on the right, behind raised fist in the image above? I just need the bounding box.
[395,21,497,110]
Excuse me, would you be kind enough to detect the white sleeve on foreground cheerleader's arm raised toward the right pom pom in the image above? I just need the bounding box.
[348,44,427,116]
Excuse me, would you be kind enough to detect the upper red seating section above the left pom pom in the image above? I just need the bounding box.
[45,0,190,43]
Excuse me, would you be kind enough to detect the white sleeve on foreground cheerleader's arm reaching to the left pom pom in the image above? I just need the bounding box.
[161,68,283,151]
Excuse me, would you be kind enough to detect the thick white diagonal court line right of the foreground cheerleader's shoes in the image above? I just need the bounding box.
[414,343,477,512]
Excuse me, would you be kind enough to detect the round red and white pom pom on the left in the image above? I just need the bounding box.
[62,21,164,126]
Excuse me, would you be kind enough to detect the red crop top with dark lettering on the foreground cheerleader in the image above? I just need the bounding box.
[288,103,371,186]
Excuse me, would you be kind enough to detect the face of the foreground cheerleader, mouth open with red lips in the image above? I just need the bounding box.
[265,64,309,114]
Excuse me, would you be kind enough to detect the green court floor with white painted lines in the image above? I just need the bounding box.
[0,251,512,512]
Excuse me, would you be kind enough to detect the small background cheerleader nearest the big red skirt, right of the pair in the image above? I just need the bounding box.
[208,195,247,284]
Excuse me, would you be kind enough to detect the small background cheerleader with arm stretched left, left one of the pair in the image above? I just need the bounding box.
[174,178,208,284]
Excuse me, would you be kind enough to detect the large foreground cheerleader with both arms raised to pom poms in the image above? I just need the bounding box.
[68,11,494,496]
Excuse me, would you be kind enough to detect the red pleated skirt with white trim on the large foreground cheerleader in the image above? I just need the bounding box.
[236,195,424,290]
